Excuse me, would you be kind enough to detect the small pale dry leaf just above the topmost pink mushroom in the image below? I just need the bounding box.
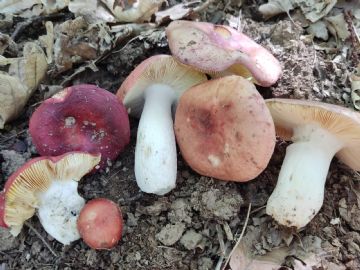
[155,0,201,24]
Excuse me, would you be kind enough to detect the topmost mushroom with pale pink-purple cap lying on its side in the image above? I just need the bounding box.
[166,20,282,86]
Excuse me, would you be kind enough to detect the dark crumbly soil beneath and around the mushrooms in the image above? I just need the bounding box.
[0,1,360,270]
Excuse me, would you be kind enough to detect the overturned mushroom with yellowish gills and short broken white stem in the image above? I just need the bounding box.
[0,152,100,245]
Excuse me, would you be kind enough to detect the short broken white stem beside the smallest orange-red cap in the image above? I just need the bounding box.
[38,180,85,245]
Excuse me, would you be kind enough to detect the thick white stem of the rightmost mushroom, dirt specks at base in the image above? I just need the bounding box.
[266,124,343,228]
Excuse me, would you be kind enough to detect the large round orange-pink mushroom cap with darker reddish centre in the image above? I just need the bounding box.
[175,75,275,182]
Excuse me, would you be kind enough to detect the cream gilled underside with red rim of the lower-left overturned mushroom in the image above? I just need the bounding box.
[4,152,101,236]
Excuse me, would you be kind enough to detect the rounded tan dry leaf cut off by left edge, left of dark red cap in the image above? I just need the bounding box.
[0,73,29,129]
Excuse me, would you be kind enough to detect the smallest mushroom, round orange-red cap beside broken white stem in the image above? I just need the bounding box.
[77,198,123,249]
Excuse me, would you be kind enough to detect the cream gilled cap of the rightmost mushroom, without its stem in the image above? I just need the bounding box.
[266,98,360,171]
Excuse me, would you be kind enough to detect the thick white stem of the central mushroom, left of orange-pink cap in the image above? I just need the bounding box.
[135,84,177,195]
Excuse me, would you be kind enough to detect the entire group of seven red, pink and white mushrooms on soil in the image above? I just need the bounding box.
[0,16,360,253]
